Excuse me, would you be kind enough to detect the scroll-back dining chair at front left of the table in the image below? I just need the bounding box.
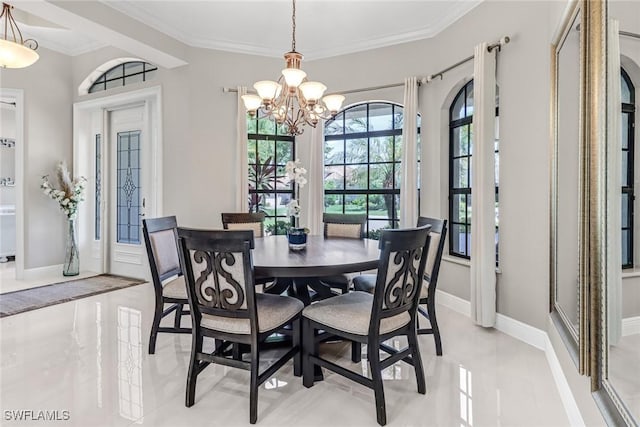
[178,228,304,424]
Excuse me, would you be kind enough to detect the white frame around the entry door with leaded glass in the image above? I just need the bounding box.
[73,86,163,278]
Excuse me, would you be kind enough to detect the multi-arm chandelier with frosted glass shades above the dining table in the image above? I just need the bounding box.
[242,0,344,136]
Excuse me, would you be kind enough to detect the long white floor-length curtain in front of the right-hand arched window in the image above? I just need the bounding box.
[470,43,496,327]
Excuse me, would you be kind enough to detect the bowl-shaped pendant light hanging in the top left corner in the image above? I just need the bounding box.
[0,3,39,68]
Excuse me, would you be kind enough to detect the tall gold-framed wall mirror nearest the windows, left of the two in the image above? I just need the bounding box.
[550,1,588,373]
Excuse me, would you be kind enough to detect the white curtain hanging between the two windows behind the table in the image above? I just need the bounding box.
[302,120,325,235]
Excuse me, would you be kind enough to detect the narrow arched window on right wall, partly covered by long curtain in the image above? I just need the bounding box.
[449,80,499,260]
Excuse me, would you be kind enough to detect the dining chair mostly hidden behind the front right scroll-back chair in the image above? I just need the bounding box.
[352,216,447,362]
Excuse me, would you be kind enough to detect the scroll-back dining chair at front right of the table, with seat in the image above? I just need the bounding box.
[302,225,431,426]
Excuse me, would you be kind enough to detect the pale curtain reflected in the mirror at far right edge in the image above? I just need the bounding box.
[607,19,633,345]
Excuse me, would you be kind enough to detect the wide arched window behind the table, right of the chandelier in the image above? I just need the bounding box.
[324,102,420,238]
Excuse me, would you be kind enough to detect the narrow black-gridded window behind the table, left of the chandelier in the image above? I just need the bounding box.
[247,113,295,234]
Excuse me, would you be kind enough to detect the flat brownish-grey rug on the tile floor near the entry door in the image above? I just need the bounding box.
[0,274,146,317]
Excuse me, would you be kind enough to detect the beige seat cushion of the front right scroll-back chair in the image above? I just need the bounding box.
[302,291,411,335]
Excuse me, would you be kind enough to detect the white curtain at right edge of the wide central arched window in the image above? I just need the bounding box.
[400,77,418,228]
